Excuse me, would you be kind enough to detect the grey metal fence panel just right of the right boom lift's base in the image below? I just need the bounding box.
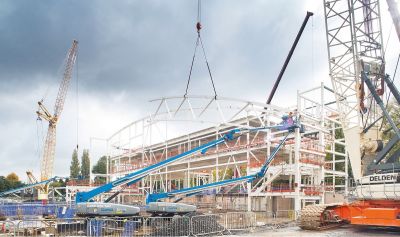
[191,214,225,236]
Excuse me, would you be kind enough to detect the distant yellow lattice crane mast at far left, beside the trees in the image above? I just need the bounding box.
[36,40,78,199]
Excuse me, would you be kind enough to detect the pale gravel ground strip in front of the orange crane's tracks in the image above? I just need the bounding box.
[231,225,400,237]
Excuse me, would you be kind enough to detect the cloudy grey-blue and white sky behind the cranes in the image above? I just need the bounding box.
[0,0,399,180]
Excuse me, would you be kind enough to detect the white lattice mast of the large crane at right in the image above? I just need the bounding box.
[324,0,385,180]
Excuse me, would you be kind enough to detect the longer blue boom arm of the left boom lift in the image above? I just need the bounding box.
[76,124,290,203]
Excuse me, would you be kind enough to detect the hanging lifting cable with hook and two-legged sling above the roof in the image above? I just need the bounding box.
[184,0,217,99]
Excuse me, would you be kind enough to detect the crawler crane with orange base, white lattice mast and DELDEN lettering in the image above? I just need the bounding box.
[299,0,400,230]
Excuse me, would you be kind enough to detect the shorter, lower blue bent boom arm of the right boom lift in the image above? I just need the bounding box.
[146,131,290,204]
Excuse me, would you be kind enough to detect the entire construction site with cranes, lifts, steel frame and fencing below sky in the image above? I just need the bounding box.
[0,0,400,236]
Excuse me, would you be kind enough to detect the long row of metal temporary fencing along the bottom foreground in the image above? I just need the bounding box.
[0,212,256,237]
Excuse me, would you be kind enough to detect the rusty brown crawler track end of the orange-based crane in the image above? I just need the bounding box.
[299,204,343,230]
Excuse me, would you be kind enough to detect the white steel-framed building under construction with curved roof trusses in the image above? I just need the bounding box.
[67,85,349,215]
